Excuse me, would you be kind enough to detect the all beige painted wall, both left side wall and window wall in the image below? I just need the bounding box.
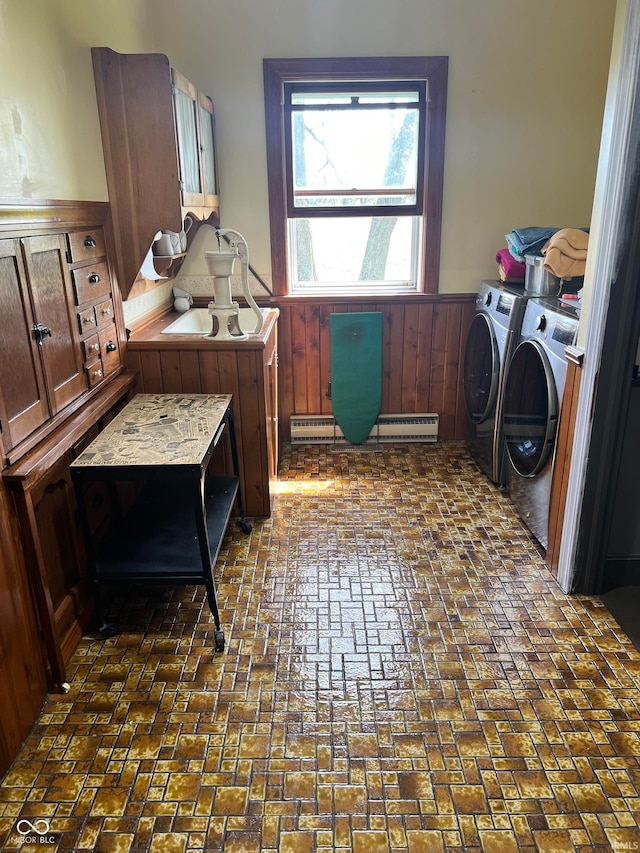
[0,0,615,291]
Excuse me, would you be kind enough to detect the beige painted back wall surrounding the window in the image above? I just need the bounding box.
[153,0,615,291]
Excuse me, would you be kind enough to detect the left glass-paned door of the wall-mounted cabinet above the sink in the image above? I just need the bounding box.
[171,69,203,207]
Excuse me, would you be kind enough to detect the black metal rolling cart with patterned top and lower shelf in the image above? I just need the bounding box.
[70,394,251,651]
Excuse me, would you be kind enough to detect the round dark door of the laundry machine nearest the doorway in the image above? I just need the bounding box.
[502,340,558,477]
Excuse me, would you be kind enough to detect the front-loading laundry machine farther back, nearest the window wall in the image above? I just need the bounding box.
[463,281,526,486]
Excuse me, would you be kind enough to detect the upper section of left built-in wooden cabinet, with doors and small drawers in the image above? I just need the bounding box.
[0,211,121,459]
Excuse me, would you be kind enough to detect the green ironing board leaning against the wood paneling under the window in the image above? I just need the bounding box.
[329,311,382,444]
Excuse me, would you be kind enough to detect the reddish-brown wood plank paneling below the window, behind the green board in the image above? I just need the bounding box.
[277,294,475,441]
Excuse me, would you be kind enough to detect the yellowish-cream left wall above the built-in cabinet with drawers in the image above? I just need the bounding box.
[0,0,153,201]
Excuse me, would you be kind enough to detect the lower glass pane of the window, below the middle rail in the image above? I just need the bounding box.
[289,216,420,290]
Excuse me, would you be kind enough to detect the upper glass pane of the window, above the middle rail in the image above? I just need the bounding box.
[292,106,419,207]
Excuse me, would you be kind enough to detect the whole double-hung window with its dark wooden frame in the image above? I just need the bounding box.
[264,57,447,295]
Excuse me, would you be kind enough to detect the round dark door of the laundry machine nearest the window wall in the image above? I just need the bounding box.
[463,313,500,424]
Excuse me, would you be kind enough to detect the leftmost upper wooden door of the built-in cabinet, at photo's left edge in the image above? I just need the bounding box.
[0,240,49,451]
